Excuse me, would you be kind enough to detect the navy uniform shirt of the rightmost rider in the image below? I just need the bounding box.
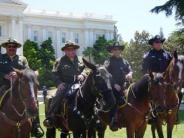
[142,49,172,74]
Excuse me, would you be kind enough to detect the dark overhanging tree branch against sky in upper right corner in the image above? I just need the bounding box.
[151,0,184,23]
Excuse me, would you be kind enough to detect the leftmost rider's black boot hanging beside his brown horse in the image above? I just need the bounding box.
[31,103,44,138]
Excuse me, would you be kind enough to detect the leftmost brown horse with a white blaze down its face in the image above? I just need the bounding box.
[0,69,38,138]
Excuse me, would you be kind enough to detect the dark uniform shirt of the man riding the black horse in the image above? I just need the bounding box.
[52,55,84,86]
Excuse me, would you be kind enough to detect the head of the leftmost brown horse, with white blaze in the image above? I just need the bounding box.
[14,69,39,117]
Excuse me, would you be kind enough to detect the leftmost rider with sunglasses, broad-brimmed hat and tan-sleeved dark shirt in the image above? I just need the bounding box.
[0,38,43,137]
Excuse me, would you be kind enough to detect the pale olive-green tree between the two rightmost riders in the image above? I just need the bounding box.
[123,31,150,80]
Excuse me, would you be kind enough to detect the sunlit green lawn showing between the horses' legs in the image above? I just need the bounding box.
[40,104,184,138]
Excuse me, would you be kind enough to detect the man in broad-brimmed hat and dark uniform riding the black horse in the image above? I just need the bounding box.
[44,42,85,128]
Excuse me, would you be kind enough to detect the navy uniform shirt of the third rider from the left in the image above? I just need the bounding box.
[104,57,132,86]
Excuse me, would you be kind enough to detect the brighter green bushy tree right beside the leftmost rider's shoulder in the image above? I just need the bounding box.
[23,40,41,70]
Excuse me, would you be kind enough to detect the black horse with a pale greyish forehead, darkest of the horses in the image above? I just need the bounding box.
[44,59,115,138]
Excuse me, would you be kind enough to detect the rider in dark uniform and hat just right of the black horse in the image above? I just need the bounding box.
[104,42,133,131]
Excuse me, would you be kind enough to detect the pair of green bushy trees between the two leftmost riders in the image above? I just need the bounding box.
[24,38,55,87]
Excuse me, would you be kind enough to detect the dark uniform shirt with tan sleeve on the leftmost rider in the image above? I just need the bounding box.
[0,54,29,83]
